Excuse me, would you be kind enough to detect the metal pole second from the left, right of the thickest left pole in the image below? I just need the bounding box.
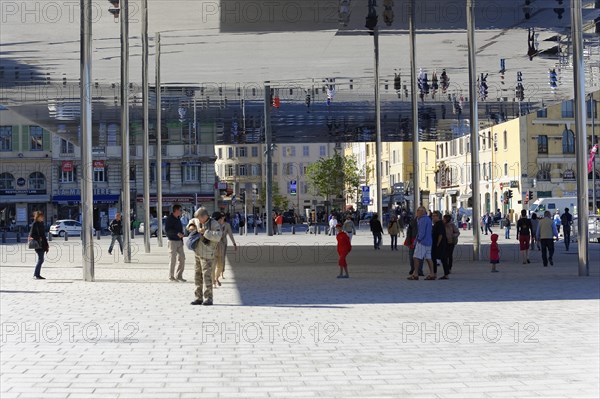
[121,0,131,263]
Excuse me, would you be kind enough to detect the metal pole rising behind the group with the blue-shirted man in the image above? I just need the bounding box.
[408,0,421,215]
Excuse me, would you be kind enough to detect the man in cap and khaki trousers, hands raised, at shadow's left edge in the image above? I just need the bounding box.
[187,207,223,306]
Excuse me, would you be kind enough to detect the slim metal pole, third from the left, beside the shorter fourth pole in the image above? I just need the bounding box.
[141,0,150,253]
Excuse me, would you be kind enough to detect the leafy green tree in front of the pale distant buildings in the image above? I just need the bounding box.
[306,151,360,206]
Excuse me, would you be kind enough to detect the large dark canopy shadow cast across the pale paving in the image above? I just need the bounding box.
[227,244,600,307]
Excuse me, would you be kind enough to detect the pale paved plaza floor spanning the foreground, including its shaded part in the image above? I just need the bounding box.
[0,230,600,399]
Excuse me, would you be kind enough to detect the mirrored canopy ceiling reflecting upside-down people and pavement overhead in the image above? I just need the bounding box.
[0,0,600,143]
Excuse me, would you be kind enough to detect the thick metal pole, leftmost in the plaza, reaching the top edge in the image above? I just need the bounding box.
[79,0,94,281]
